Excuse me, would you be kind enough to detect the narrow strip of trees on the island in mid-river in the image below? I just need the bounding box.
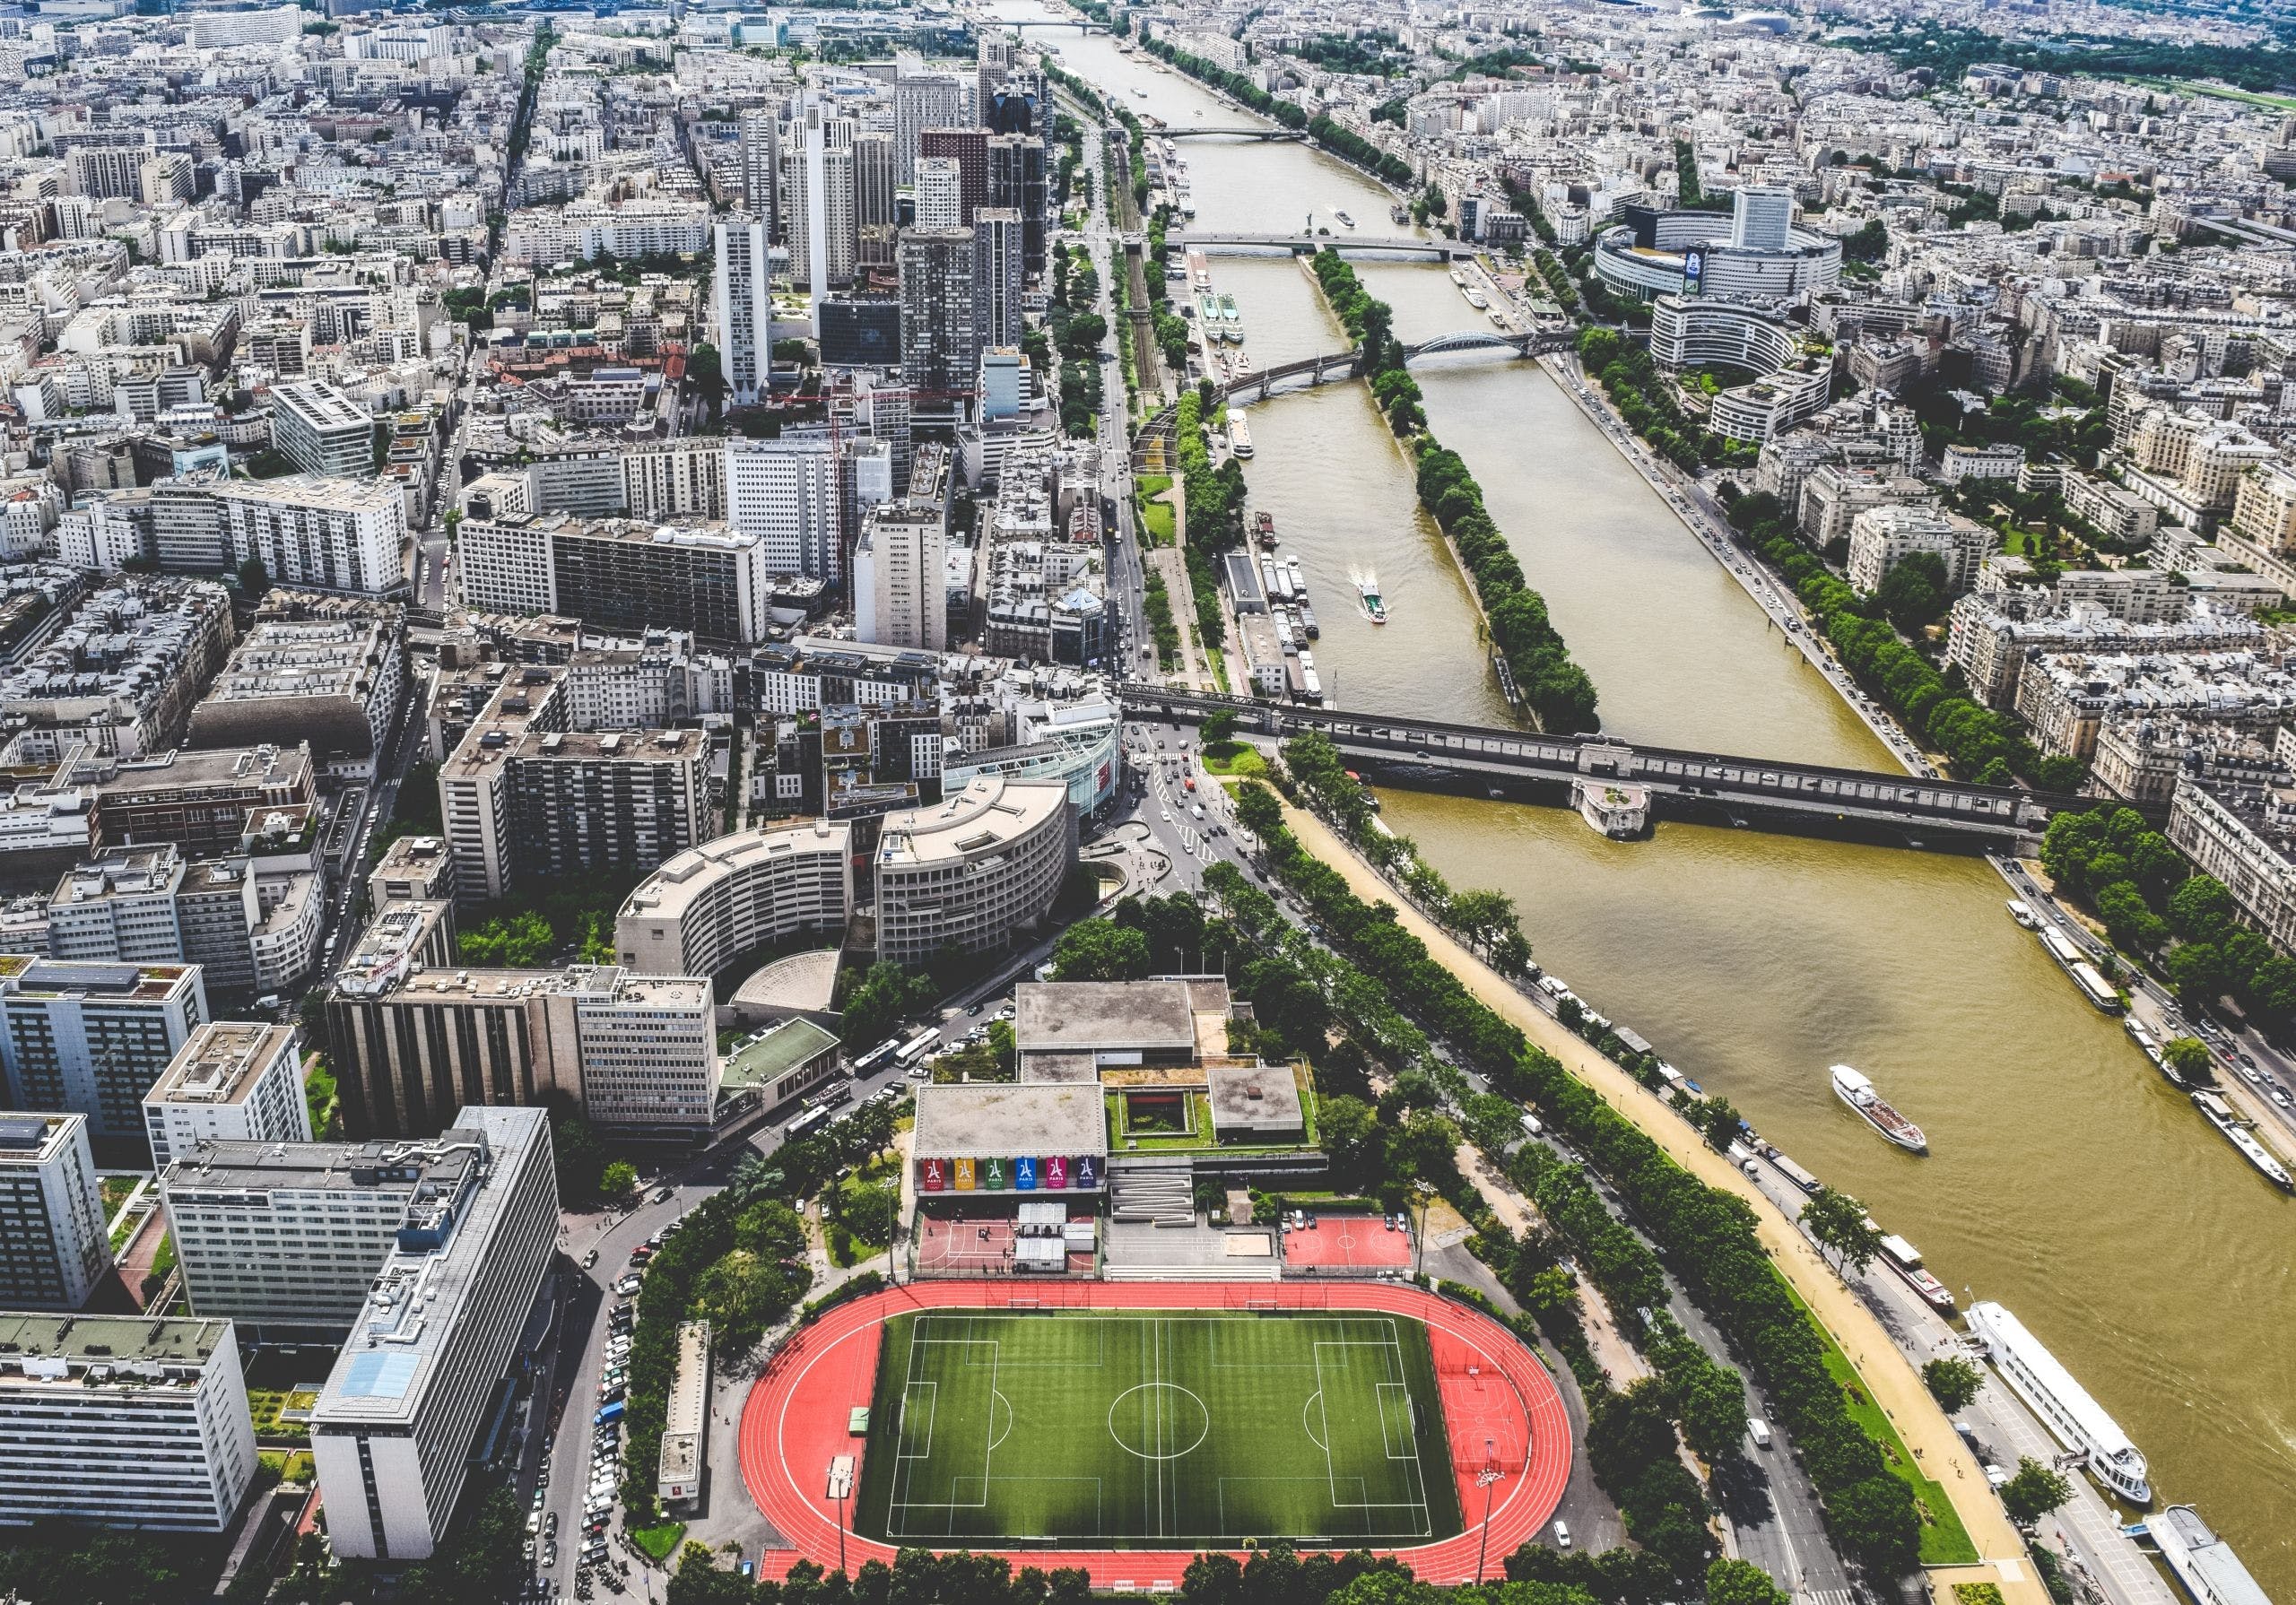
[1311,250,1600,733]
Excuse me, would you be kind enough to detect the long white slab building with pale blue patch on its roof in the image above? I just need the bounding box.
[310,1106,558,1561]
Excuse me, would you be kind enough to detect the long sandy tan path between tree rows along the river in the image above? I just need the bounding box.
[1283,806,2048,1605]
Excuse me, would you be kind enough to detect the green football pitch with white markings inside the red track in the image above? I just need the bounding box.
[854,1311,1460,1548]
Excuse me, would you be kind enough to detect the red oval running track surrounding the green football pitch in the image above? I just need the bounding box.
[739,1286,1570,1589]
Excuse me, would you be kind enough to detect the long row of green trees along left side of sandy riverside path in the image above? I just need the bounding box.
[1205,783,1922,1575]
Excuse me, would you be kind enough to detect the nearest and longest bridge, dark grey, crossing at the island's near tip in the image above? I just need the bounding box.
[1123,682,2096,840]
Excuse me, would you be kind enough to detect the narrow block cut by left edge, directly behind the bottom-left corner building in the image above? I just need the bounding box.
[0,1114,112,1311]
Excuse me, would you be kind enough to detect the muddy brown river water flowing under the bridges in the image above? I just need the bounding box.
[1008,0,2296,1601]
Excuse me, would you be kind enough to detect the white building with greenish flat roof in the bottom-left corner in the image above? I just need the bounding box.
[0,1315,255,1534]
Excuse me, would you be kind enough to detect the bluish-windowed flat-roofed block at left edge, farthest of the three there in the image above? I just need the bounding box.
[0,955,206,1139]
